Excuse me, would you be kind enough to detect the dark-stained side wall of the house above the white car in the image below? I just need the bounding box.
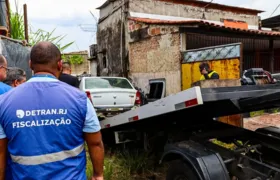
[97,1,128,76]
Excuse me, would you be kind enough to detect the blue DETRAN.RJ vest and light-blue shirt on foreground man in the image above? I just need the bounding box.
[0,76,101,179]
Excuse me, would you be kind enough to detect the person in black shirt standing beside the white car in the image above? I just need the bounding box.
[59,62,80,88]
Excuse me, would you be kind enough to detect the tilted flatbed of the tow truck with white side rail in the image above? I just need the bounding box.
[100,85,280,129]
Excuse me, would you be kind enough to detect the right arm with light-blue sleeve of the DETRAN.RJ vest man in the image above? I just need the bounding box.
[83,99,104,180]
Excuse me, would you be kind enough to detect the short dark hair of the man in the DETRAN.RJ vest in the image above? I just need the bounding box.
[30,42,61,65]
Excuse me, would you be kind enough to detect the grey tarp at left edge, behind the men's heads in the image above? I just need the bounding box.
[0,38,32,79]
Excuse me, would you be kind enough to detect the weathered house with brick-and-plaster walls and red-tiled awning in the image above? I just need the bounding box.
[97,0,279,95]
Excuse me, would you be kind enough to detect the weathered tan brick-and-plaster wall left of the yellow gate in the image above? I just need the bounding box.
[129,26,181,95]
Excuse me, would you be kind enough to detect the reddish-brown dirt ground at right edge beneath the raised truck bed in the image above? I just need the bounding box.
[244,113,280,131]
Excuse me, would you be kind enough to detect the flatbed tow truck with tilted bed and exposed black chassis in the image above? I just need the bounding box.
[100,84,280,180]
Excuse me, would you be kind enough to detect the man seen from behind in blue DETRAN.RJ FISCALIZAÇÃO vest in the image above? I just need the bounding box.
[0,42,104,180]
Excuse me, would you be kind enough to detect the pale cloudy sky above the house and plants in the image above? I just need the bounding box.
[10,0,280,52]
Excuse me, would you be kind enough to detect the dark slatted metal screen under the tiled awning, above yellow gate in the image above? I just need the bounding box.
[187,33,280,71]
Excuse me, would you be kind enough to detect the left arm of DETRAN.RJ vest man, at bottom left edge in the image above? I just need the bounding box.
[0,125,8,180]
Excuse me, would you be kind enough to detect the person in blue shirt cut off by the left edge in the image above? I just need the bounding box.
[0,55,12,95]
